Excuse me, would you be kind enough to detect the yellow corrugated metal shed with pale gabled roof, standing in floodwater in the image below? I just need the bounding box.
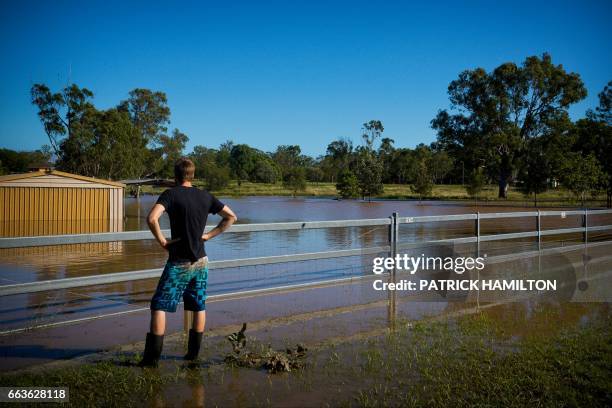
[0,169,125,236]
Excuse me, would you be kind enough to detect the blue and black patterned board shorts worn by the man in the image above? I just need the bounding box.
[151,256,208,312]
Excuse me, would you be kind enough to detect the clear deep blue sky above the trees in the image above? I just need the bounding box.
[0,0,612,156]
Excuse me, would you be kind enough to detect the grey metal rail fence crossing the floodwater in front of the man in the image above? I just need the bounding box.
[0,210,612,297]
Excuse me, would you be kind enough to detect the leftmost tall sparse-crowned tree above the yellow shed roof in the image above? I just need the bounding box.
[30,84,93,154]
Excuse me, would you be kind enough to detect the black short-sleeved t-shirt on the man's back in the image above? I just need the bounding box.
[157,186,224,262]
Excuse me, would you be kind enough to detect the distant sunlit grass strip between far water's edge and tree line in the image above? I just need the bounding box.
[135,180,605,206]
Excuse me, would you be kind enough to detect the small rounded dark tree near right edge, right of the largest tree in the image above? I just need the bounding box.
[561,152,604,207]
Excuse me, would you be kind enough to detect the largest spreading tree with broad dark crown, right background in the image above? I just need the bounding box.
[432,53,586,198]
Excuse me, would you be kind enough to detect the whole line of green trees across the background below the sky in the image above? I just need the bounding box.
[0,54,612,205]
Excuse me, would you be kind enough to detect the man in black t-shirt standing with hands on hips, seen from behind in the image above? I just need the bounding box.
[139,158,237,367]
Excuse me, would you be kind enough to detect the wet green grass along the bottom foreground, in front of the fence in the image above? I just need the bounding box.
[0,313,612,407]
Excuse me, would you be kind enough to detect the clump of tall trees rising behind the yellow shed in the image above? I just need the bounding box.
[31,84,167,178]
